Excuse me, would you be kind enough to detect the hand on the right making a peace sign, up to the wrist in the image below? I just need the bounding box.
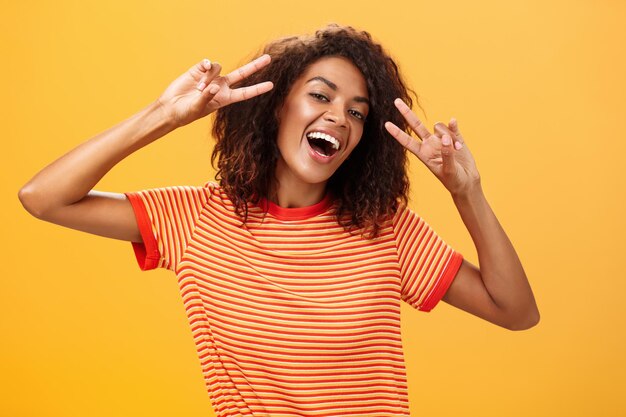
[385,99,480,197]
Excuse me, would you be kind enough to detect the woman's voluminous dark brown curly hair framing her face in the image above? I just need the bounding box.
[211,24,415,238]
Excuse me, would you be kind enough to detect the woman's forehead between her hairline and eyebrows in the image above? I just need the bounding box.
[296,56,368,97]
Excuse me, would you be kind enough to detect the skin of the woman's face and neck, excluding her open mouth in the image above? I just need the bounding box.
[272,57,369,207]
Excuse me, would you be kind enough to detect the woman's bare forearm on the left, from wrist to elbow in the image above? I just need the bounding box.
[20,102,175,214]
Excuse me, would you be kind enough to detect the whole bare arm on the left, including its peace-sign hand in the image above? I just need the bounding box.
[18,55,272,242]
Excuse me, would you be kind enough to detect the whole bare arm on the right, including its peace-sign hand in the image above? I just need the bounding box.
[385,99,539,330]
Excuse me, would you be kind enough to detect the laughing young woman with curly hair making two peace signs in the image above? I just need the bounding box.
[19,26,539,416]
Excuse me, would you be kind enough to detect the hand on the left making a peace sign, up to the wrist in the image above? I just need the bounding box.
[157,55,274,127]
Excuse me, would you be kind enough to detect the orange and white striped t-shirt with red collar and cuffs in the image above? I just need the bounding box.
[126,183,462,417]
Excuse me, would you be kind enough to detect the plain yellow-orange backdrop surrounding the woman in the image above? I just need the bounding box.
[0,0,626,417]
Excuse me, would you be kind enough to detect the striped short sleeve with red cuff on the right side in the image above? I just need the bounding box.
[393,206,463,312]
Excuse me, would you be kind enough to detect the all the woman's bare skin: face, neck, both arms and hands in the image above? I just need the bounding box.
[18,50,539,330]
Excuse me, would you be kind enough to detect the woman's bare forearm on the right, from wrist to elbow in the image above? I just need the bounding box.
[453,184,539,322]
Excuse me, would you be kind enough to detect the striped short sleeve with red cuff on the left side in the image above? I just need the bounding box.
[125,183,212,271]
